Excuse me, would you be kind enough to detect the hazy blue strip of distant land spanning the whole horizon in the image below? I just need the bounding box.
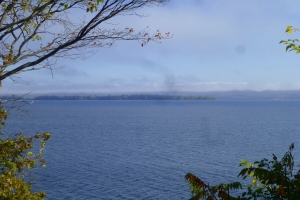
[4,90,300,100]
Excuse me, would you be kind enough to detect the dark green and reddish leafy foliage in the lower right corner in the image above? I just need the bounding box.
[185,144,300,200]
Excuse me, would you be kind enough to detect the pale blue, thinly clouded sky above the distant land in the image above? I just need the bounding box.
[1,0,300,94]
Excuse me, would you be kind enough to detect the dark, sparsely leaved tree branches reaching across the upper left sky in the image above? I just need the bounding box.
[0,0,170,84]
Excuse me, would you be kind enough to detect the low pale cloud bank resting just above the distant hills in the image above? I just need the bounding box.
[1,72,300,95]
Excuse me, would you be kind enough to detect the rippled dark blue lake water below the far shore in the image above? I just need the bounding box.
[5,100,300,199]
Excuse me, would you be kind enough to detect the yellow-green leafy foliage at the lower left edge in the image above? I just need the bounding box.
[0,104,51,200]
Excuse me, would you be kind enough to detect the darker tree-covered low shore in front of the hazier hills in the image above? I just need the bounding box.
[33,94,216,101]
